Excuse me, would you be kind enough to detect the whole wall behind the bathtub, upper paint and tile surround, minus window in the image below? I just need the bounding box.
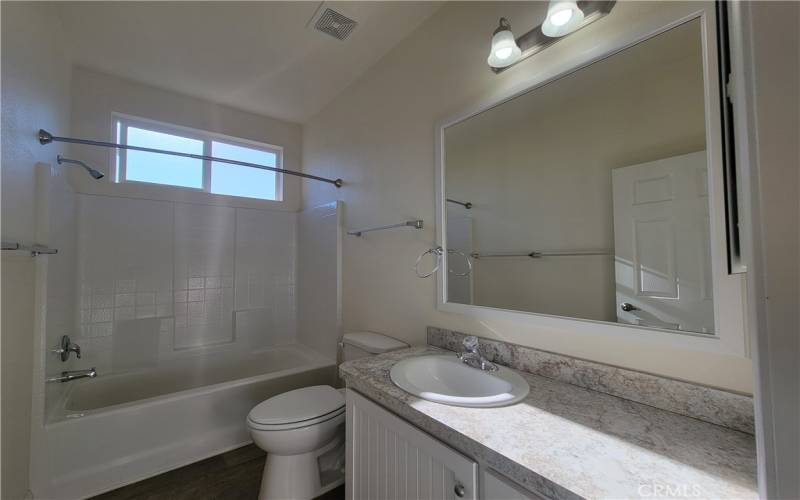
[51,67,310,382]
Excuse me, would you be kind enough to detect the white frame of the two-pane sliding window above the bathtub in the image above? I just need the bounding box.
[109,112,286,203]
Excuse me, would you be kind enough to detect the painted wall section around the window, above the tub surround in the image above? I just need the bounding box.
[65,67,302,211]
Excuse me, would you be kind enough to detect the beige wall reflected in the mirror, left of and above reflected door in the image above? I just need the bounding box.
[445,20,705,321]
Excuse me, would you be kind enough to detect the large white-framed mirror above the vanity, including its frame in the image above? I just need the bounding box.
[437,4,746,354]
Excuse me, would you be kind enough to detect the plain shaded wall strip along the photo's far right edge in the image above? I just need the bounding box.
[732,2,800,498]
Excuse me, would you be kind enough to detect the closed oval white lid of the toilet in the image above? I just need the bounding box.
[248,385,344,425]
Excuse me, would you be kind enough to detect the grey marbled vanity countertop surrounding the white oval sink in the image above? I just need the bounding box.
[340,347,758,500]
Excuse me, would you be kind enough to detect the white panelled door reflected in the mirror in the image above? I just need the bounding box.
[612,151,714,333]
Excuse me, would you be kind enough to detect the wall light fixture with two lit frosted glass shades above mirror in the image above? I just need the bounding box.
[487,0,617,73]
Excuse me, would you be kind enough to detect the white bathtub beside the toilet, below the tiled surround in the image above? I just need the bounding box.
[33,345,336,499]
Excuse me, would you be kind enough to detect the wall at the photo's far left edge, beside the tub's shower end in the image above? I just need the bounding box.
[1,2,70,498]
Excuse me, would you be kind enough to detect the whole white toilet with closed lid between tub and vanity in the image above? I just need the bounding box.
[247,332,408,500]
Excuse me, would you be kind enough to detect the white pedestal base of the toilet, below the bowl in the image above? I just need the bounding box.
[258,437,344,500]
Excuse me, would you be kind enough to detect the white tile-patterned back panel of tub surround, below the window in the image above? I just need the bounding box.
[69,194,297,375]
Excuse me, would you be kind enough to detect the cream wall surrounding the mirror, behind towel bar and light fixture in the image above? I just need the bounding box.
[303,2,752,393]
